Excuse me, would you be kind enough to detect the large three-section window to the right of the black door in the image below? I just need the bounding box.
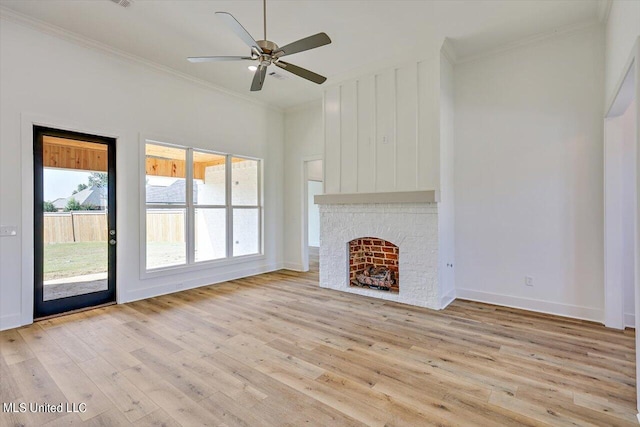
[145,141,262,270]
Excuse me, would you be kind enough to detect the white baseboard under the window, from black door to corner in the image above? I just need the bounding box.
[121,264,283,303]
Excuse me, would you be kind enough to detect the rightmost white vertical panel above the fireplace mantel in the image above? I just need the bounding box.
[416,60,440,190]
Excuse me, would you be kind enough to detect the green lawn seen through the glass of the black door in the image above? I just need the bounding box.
[44,242,108,280]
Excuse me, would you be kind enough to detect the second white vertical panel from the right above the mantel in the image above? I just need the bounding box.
[396,64,418,191]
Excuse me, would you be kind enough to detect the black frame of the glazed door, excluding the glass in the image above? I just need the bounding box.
[33,125,117,318]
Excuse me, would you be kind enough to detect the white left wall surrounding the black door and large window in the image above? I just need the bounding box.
[0,18,284,328]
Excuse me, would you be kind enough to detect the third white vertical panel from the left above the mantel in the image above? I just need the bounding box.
[357,76,376,193]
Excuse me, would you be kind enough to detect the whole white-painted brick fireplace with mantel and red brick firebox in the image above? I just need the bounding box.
[315,191,444,309]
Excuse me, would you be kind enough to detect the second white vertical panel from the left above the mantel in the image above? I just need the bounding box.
[340,80,358,193]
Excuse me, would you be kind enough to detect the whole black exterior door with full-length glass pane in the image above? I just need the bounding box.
[33,126,117,319]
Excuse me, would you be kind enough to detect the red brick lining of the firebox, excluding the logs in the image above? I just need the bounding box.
[349,237,400,293]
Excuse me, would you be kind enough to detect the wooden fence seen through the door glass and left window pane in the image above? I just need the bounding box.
[44,209,185,244]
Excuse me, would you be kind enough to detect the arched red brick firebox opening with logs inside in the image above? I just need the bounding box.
[349,237,400,293]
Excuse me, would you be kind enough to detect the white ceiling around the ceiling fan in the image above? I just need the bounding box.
[0,0,604,108]
